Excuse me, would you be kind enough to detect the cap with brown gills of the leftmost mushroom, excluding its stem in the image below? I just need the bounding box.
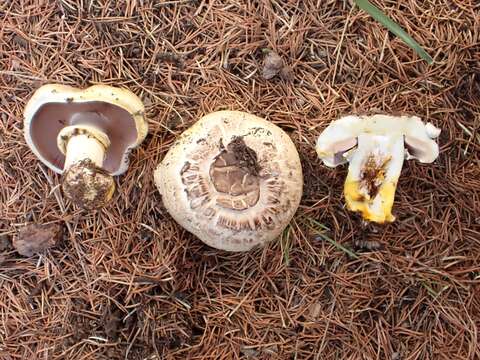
[24,84,148,175]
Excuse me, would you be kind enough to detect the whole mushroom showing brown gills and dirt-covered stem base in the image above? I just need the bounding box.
[24,84,148,209]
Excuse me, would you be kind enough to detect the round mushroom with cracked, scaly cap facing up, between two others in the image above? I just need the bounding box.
[155,111,303,251]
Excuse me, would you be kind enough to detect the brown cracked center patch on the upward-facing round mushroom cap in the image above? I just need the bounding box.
[210,137,260,210]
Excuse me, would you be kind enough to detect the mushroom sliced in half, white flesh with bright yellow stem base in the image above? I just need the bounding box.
[316,115,440,223]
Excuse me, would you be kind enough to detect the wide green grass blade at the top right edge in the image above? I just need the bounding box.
[355,0,433,64]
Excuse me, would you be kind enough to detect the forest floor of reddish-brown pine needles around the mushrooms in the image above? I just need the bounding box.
[0,0,480,360]
